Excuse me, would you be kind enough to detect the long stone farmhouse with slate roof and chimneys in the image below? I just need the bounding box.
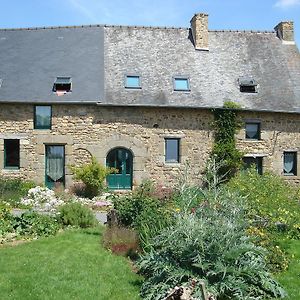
[0,13,300,189]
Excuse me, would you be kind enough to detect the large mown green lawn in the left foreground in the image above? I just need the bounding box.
[0,228,141,300]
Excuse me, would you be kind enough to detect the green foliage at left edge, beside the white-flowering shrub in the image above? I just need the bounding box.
[0,177,35,207]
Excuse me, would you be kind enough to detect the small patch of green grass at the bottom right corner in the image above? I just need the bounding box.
[277,240,300,300]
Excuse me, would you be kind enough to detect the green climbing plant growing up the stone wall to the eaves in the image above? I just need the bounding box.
[212,102,242,178]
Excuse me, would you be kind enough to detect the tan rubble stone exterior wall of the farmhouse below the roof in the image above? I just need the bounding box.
[0,104,300,186]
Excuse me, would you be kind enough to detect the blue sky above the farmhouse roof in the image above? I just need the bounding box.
[0,0,300,48]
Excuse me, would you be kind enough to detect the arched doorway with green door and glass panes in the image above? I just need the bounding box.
[106,148,133,190]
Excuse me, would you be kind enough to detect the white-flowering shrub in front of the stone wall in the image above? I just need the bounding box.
[21,186,64,213]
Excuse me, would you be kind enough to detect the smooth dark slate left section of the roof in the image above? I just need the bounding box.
[0,27,104,103]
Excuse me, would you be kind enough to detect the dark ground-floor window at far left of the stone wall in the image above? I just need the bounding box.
[4,140,20,169]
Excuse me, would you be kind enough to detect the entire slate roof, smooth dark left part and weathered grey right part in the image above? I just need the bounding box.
[0,22,300,113]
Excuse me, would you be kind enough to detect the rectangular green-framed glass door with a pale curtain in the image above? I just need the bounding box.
[45,145,65,189]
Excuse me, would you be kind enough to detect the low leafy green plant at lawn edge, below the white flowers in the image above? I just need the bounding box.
[12,211,60,237]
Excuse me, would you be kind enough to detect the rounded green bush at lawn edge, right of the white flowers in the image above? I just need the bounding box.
[58,203,97,228]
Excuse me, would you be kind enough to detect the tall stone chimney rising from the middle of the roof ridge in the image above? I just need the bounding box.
[191,13,208,51]
